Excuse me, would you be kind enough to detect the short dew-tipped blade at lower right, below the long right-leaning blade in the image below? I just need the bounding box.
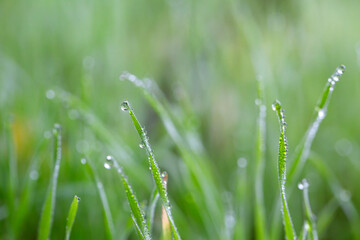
[298,179,319,240]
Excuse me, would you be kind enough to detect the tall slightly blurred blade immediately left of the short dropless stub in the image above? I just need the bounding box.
[38,124,61,240]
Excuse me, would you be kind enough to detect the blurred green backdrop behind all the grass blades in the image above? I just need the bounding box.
[0,0,360,239]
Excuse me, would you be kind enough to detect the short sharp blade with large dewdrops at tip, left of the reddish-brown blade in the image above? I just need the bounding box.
[104,156,151,240]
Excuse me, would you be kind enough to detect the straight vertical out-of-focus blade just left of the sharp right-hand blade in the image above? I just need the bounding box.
[254,80,267,240]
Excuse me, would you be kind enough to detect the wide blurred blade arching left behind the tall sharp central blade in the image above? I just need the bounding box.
[120,72,225,238]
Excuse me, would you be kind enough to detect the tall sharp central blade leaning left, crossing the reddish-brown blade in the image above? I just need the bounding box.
[121,101,181,240]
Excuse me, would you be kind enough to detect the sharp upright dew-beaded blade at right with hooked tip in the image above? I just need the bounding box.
[272,101,296,240]
